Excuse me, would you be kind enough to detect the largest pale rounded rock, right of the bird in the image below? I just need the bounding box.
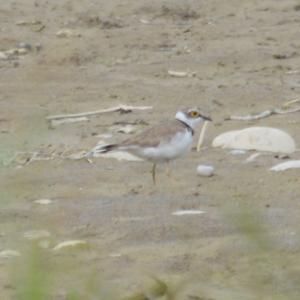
[212,127,296,153]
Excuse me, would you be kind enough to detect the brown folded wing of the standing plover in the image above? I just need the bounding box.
[118,120,186,147]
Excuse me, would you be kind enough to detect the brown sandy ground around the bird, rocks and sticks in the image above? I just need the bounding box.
[0,0,300,300]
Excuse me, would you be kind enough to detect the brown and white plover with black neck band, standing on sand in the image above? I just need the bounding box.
[88,107,212,184]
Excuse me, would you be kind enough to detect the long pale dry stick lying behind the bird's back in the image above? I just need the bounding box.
[46,104,152,120]
